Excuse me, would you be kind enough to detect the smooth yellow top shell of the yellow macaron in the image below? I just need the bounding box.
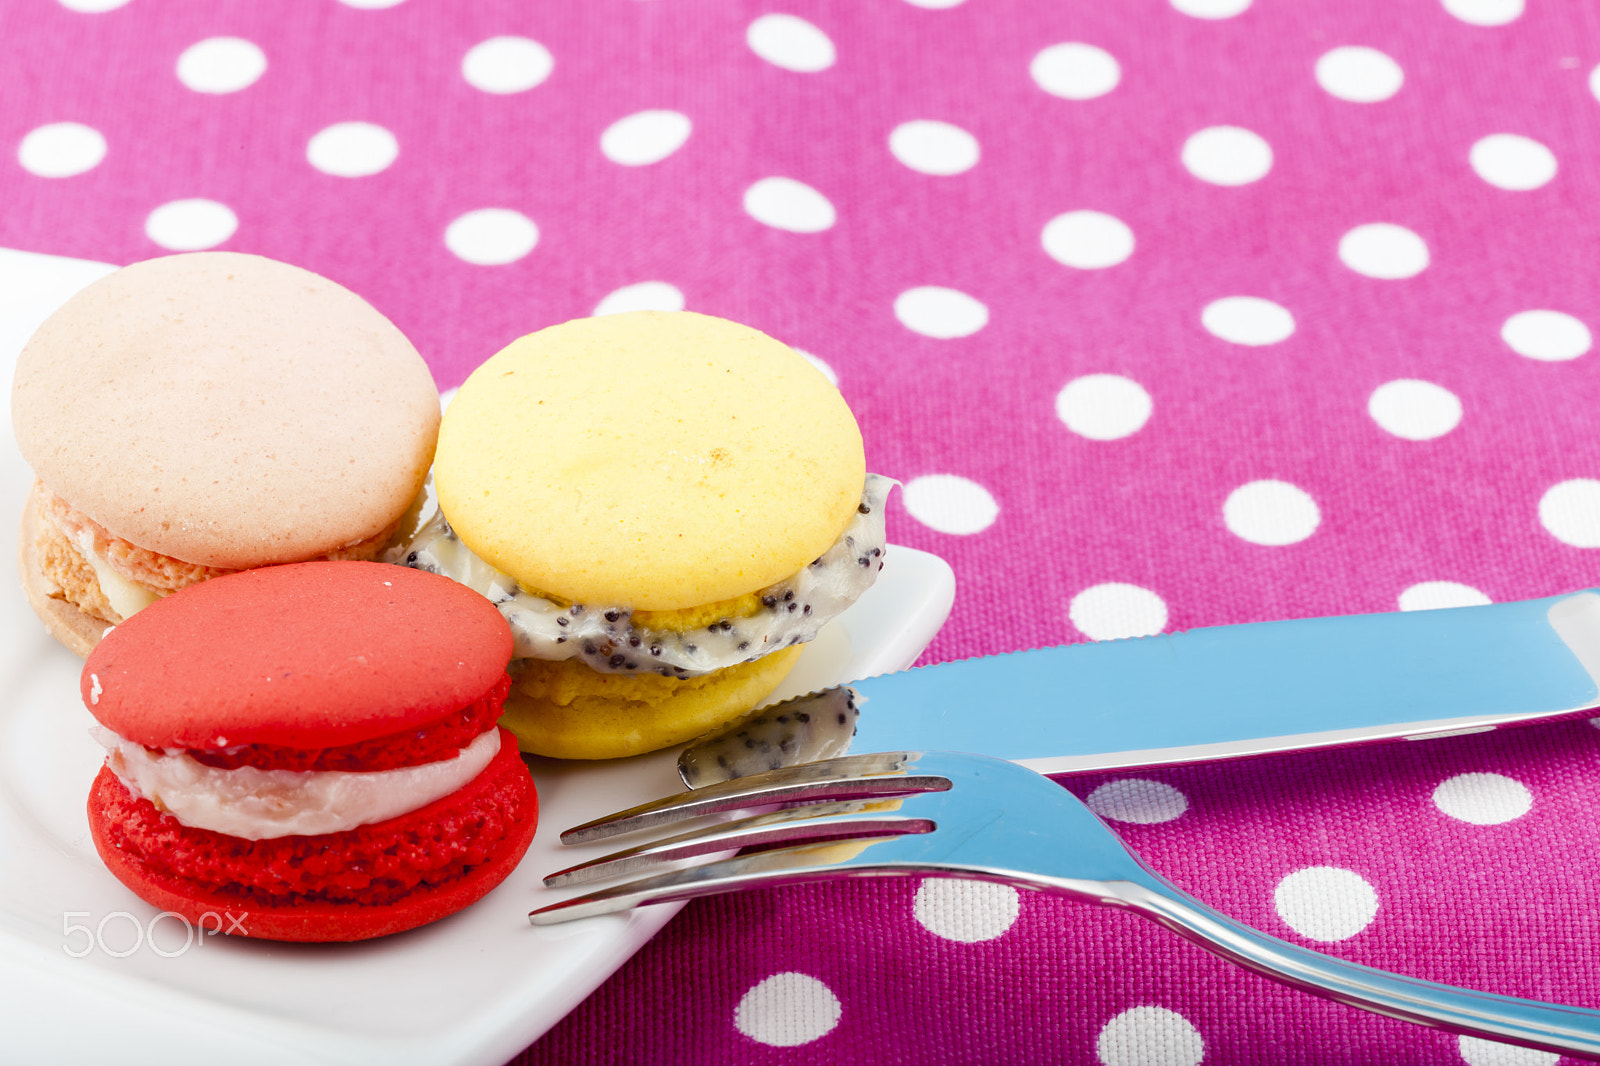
[434,311,866,610]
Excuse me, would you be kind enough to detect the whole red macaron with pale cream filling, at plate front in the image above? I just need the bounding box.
[82,562,538,941]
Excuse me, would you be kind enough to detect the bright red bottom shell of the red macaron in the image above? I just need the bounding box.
[88,735,539,943]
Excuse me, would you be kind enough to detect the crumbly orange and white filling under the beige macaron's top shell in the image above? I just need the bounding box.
[34,480,400,624]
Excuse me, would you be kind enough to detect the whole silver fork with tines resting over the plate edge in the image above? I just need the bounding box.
[528,752,1600,1056]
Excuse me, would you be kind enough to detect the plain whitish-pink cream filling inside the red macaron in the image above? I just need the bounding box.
[91,727,501,840]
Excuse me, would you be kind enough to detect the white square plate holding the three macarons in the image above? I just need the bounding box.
[0,250,955,1066]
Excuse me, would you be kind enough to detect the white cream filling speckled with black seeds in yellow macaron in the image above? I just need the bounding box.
[386,474,894,679]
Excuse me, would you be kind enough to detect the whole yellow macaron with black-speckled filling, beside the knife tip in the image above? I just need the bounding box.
[425,311,875,759]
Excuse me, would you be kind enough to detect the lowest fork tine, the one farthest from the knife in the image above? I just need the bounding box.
[528,837,912,925]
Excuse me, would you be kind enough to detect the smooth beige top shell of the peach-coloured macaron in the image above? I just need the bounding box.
[11,251,438,568]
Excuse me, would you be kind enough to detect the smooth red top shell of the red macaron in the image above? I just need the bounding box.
[80,562,512,749]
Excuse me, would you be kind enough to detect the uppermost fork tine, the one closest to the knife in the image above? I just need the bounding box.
[562,742,950,844]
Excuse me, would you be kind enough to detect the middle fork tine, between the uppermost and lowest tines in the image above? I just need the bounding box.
[544,799,933,888]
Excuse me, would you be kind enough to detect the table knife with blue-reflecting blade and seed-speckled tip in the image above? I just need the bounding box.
[678,589,1600,787]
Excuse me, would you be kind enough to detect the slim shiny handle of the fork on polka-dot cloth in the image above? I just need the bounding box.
[1107,880,1600,1056]
